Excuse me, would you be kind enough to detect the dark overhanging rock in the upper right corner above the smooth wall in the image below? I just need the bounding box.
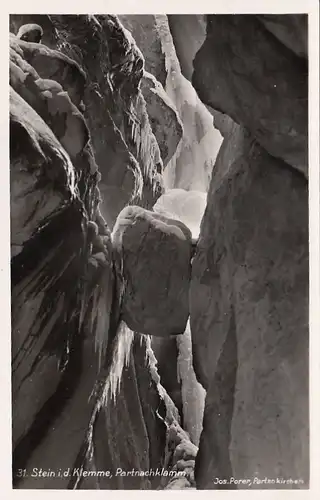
[192,15,308,177]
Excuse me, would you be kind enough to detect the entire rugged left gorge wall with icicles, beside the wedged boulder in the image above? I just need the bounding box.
[10,16,193,489]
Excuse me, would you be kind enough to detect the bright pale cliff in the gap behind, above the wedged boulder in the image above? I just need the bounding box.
[119,15,221,191]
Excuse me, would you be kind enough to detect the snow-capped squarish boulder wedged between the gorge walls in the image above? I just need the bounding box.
[112,206,192,337]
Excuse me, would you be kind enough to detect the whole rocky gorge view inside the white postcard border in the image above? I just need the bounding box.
[10,14,309,490]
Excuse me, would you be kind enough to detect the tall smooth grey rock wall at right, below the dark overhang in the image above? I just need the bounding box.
[190,124,309,489]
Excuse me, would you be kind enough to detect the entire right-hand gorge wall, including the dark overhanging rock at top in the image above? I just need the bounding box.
[169,15,309,489]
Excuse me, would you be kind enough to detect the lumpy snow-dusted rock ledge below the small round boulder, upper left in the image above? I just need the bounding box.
[10,36,89,164]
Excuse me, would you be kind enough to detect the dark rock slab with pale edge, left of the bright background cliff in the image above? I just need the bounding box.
[141,72,183,167]
